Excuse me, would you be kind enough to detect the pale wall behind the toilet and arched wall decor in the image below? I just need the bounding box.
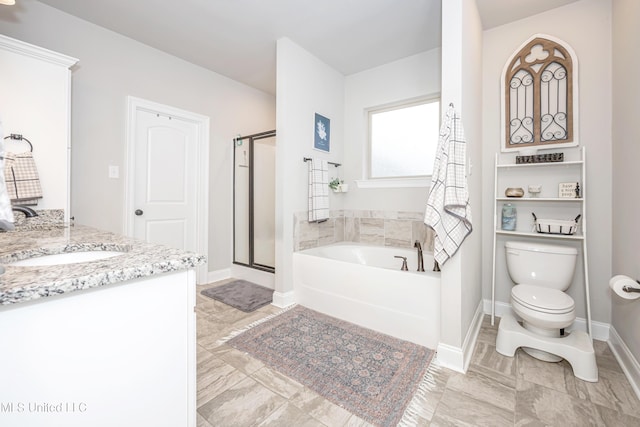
[482,0,612,323]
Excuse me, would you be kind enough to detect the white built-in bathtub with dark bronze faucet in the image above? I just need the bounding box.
[293,243,440,349]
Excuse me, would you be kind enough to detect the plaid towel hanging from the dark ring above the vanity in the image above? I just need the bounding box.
[4,151,42,205]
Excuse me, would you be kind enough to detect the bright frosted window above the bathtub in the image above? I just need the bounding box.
[369,98,440,179]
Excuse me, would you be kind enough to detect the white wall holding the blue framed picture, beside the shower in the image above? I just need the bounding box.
[274,38,344,305]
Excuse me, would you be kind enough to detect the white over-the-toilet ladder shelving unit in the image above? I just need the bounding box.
[491,147,591,336]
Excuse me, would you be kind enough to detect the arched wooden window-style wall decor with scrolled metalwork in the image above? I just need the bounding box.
[503,36,577,151]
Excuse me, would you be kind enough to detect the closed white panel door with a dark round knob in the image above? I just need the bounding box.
[131,110,198,251]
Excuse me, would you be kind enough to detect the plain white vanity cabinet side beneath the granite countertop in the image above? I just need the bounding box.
[0,269,196,427]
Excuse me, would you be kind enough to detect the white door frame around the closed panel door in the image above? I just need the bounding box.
[123,96,209,284]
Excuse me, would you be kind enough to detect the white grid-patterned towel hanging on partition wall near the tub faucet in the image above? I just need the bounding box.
[424,105,472,265]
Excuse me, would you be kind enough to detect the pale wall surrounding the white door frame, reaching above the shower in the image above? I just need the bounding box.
[0,1,275,271]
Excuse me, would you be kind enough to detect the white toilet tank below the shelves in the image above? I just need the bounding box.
[504,242,578,291]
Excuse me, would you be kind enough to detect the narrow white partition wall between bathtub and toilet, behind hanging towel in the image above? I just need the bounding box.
[438,0,482,371]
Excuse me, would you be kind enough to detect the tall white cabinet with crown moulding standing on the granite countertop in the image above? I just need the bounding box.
[0,35,78,222]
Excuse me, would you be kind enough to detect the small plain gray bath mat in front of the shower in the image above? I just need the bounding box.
[200,280,273,313]
